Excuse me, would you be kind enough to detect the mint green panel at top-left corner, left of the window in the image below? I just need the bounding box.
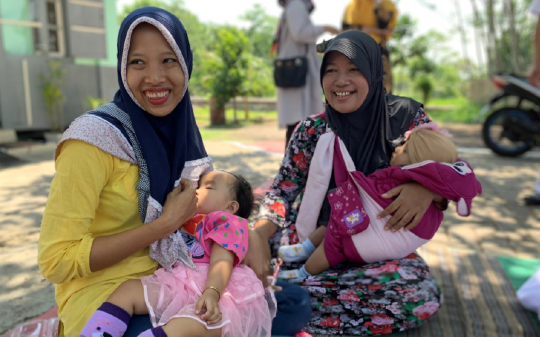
[0,0,34,55]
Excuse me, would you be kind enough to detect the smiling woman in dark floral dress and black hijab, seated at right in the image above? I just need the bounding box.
[248,31,454,335]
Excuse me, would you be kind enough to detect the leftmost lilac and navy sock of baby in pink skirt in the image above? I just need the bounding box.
[79,302,131,337]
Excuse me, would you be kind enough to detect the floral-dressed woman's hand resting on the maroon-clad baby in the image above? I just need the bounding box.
[377,182,436,232]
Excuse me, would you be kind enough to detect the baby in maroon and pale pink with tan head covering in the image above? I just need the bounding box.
[278,124,482,279]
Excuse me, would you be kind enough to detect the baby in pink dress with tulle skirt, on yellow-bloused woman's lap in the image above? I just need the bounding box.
[80,171,275,337]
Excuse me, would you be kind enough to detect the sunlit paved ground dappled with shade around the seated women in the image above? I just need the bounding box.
[0,123,540,335]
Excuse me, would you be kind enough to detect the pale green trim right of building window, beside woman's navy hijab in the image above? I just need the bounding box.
[75,0,120,68]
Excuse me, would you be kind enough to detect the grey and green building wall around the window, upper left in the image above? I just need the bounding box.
[0,0,119,130]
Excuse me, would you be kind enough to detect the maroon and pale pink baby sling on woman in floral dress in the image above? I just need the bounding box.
[296,132,481,266]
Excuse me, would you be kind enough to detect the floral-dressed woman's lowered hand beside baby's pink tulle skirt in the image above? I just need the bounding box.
[242,220,278,288]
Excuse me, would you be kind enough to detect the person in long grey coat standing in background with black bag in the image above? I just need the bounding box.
[271,0,339,147]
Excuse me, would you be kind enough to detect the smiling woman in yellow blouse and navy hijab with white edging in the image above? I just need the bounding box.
[38,8,212,336]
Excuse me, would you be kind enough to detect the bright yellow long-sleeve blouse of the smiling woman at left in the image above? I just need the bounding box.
[38,140,158,337]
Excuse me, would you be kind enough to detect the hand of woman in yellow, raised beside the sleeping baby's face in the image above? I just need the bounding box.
[160,180,197,234]
